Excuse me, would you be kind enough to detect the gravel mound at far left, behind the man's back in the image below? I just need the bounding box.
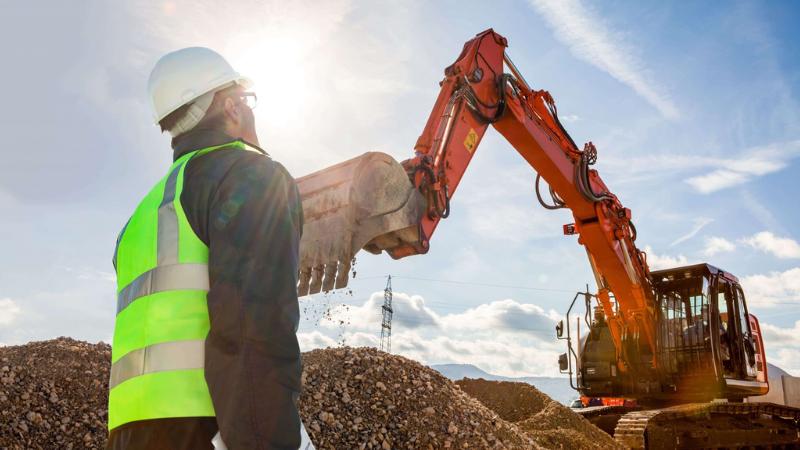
[0,338,111,449]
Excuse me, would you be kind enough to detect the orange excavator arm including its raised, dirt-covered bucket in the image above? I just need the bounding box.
[298,29,656,371]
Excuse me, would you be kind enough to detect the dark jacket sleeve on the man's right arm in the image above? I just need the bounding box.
[198,153,303,450]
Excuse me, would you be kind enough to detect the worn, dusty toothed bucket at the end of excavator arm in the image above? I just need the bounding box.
[297,152,424,296]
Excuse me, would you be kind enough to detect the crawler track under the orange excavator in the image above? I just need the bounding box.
[614,403,800,450]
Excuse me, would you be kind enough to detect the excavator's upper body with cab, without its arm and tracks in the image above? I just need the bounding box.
[562,264,768,402]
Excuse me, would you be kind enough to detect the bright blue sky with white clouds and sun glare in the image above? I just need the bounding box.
[0,0,800,375]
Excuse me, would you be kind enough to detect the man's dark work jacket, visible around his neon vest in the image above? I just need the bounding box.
[107,129,303,450]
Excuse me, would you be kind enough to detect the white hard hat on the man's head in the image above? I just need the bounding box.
[147,47,253,123]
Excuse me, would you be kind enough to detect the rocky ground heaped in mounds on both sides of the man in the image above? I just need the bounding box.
[0,338,616,450]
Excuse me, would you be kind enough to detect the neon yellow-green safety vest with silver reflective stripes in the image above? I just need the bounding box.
[108,141,256,430]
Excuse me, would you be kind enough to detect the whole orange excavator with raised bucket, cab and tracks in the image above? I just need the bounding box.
[298,29,800,448]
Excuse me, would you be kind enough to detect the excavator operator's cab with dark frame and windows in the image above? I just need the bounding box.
[651,264,767,399]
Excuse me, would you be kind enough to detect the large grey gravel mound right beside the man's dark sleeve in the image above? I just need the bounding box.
[299,347,537,450]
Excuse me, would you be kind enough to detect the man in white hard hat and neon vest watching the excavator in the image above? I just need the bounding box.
[108,47,303,450]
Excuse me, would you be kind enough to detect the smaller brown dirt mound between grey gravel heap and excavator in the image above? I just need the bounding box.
[456,378,624,449]
